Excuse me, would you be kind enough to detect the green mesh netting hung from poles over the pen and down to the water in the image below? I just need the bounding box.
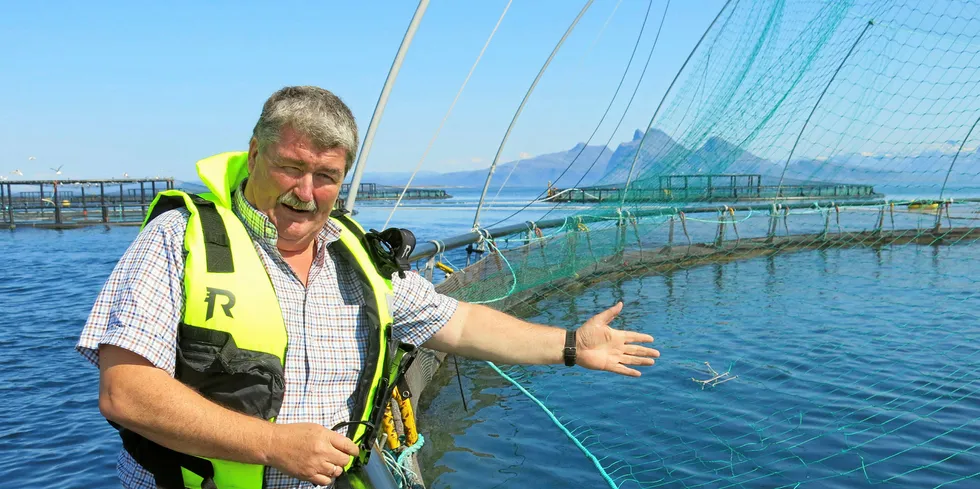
[418,0,980,487]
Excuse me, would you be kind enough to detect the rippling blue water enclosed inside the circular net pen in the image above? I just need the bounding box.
[423,245,980,488]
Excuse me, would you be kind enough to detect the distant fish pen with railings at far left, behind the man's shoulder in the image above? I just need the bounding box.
[0,178,174,229]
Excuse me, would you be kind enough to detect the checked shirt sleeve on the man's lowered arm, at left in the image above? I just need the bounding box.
[75,209,188,375]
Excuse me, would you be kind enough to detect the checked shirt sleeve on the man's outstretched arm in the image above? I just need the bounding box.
[391,271,459,346]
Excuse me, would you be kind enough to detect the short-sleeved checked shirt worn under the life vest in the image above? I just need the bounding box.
[76,183,458,489]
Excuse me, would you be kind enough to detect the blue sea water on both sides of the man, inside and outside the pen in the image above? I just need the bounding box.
[0,186,980,488]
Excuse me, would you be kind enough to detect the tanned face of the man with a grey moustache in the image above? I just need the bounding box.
[245,126,347,251]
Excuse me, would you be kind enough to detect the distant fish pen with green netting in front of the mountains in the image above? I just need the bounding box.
[546,174,884,203]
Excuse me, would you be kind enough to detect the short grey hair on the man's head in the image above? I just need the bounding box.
[252,86,358,173]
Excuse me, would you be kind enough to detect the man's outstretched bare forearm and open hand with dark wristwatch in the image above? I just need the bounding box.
[423,302,660,377]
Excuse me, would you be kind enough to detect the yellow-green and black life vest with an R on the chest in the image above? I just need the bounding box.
[117,152,405,489]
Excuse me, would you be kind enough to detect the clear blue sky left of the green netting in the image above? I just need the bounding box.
[0,0,724,179]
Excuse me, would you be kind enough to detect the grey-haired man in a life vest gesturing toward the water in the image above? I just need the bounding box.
[77,87,659,489]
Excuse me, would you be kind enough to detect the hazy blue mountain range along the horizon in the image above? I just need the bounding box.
[168,129,980,192]
